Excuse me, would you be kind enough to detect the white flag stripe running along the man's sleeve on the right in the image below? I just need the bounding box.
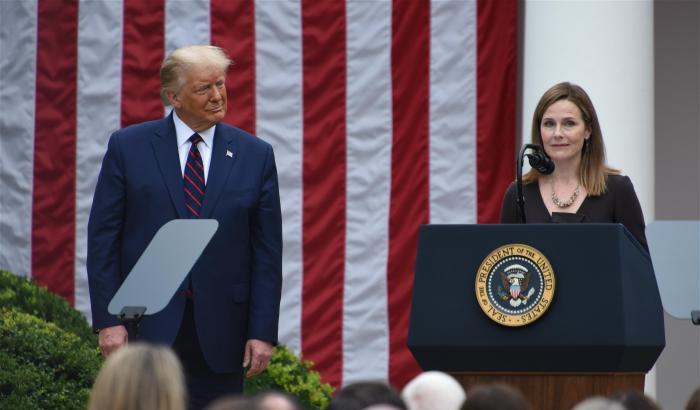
[255,1,303,353]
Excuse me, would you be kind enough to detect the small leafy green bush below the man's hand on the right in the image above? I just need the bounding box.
[245,346,333,409]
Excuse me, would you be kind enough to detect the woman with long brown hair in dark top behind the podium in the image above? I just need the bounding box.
[501,82,649,252]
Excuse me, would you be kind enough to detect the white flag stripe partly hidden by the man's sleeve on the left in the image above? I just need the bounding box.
[75,0,123,319]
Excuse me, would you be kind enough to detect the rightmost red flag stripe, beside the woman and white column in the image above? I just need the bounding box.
[476,0,518,223]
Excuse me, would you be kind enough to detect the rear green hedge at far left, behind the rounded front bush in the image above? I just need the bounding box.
[0,271,97,347]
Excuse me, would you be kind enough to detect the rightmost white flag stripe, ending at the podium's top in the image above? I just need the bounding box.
[430,0,477,224]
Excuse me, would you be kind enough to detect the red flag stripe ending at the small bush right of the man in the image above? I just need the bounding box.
[301,0,347,387]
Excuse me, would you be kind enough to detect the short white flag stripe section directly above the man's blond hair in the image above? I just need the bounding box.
[165,0,211,54]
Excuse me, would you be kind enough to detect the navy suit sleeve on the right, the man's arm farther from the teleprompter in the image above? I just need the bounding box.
[248,146,282,344]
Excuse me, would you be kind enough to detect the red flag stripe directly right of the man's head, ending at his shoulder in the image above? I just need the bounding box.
[211,0,255,134]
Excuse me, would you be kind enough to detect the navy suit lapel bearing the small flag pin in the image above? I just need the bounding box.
[200,126,238,218]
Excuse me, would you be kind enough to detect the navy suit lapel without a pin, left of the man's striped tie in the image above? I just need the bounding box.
[151,113,187,218]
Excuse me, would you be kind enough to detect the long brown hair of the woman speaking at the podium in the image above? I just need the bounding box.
[523,82,620,196]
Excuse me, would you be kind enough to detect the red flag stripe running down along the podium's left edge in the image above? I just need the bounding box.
[387,0,430,387]
